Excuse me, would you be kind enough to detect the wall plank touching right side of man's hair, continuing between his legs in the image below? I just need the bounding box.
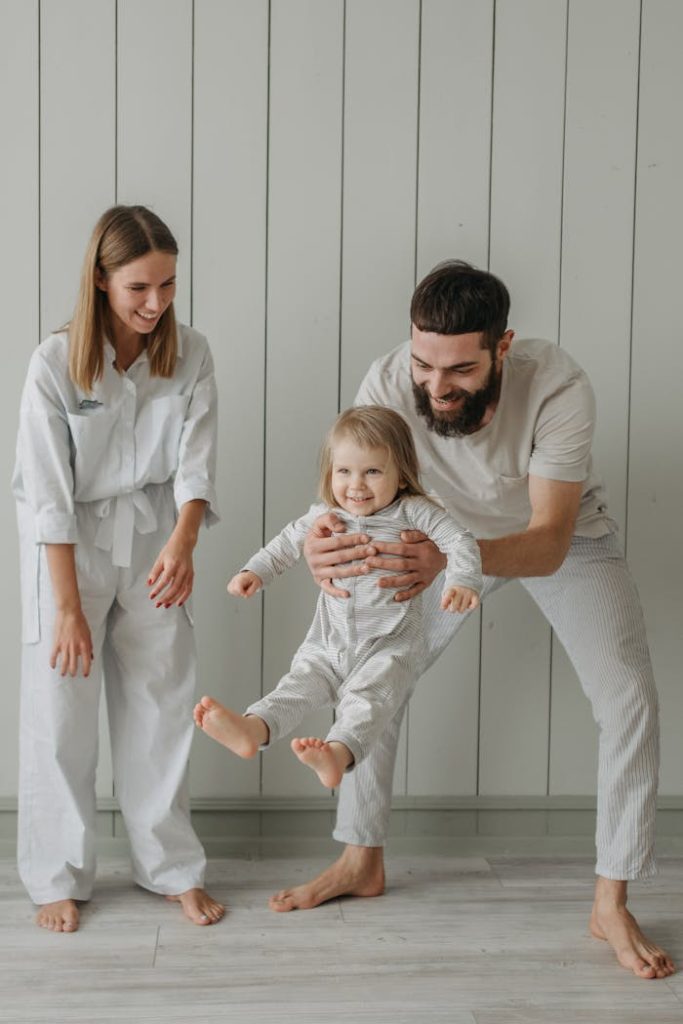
[479,0,566,794]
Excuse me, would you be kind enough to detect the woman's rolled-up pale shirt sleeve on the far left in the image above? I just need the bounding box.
[14,348,77,544]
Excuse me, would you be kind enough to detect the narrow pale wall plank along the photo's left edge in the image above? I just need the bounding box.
[0,0,39,797]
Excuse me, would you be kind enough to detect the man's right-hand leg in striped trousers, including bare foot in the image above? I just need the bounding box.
[522,537,674,978]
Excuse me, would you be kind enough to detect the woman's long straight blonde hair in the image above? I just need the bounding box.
[67,206,178,391]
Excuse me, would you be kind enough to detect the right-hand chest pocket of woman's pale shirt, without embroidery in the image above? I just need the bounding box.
[135,394,189,483]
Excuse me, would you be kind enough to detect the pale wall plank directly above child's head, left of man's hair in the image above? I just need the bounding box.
[340,0,420,793]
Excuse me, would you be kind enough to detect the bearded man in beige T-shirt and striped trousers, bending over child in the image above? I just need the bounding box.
[270,260,675,978]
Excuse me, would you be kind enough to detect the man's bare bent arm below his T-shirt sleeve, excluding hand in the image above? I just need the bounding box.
[479,474,584,578]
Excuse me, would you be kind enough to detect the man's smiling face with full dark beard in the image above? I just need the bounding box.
[411,325,512,437]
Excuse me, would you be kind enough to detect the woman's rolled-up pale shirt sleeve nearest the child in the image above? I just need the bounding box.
[173,346,219,526]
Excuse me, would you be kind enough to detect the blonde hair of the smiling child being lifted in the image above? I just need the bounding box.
[318,406,426,506]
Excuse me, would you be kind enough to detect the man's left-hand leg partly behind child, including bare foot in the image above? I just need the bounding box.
[270,575,505,911]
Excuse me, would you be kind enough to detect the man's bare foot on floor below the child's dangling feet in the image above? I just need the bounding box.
[268,846,384,913]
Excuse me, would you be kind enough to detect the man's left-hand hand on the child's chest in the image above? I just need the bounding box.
[303,512,378,597]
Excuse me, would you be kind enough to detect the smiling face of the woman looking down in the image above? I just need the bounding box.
[96,252,176,334]
